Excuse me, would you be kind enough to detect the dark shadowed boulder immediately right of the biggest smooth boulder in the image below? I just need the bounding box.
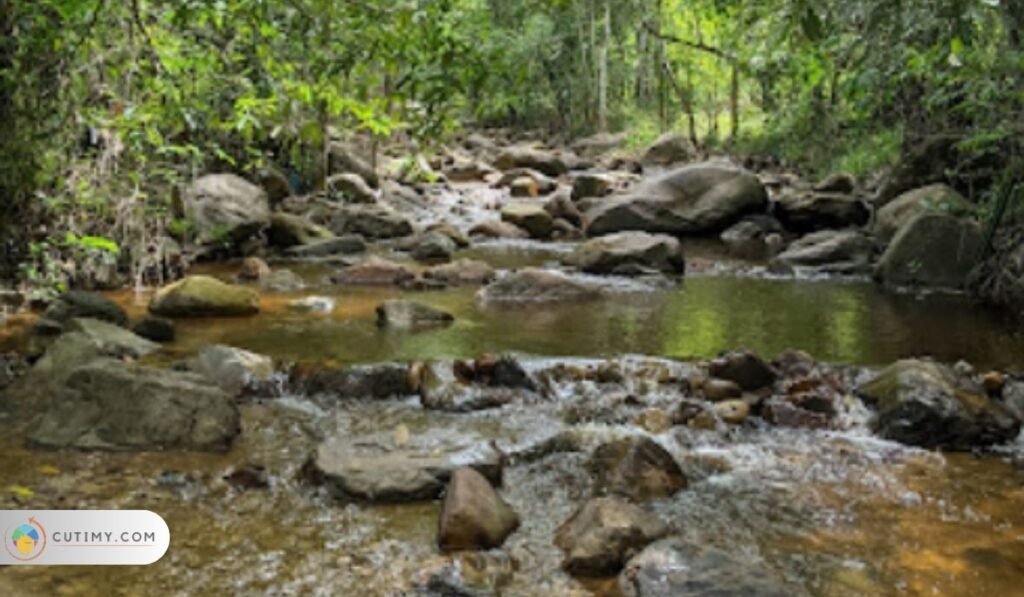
[775,190,871,233]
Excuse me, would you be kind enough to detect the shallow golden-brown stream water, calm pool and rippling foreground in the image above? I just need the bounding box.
[0,250,1024,597]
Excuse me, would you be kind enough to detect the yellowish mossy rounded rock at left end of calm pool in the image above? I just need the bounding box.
[150,275,259,317]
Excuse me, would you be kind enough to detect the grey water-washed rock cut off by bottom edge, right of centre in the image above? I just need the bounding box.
[618,538,798,597]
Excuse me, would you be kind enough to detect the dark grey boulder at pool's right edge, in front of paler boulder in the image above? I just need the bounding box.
[874,212,985,289]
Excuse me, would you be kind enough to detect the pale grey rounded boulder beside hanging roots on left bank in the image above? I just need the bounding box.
[184,174,270,244]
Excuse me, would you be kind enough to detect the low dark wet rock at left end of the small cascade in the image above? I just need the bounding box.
[292,364,416,399]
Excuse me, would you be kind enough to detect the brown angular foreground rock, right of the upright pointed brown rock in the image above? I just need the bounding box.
[555,498,669,577]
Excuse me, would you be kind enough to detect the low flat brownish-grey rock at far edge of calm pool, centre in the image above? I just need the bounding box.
[479,267,601,303]
